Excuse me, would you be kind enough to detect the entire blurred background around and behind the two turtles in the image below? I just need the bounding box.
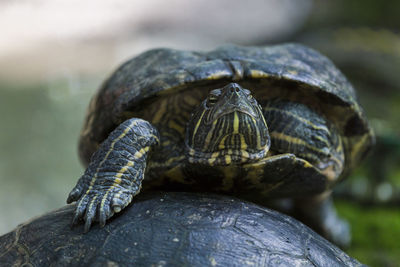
[0,0,400,266]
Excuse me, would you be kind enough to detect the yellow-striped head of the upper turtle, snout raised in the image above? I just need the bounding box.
[185,83,270,165]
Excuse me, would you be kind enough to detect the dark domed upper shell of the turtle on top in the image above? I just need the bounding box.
[79,44,374,180]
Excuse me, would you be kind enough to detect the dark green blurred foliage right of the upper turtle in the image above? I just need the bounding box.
[293,0,400,266]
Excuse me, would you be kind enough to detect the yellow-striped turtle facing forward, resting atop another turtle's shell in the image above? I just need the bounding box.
[67,43,374,247]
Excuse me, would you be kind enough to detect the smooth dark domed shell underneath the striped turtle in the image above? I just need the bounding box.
[0,192,365,267]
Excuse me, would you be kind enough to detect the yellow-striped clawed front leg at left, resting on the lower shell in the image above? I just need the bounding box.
[67,118,159,232]
